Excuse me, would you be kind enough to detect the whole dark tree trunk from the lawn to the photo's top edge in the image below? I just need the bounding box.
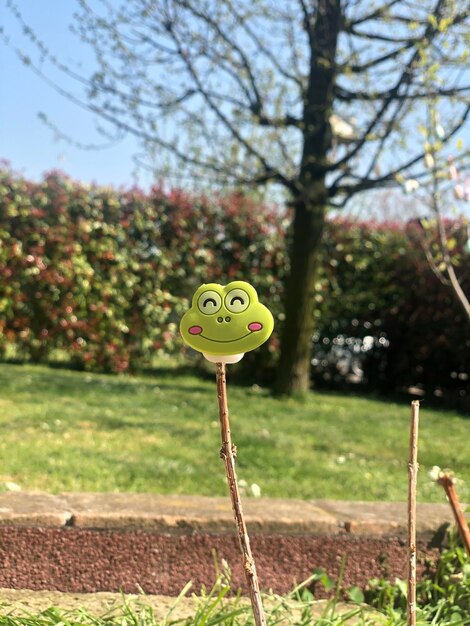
[275,0,342,395]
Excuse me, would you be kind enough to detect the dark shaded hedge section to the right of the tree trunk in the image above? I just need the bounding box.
[314,221,470,399]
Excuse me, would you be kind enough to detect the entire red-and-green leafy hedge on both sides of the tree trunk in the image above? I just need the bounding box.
[0,169,470,395]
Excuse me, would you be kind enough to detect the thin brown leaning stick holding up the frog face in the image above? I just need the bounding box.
[216,363,266,626]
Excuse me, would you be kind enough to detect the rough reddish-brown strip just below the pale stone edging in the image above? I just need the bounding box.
[0,527,437,597]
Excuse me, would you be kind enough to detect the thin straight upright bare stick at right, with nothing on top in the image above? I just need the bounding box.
[406,400,419,626]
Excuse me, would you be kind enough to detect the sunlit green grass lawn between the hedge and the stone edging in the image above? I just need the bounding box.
[0,364,470,502]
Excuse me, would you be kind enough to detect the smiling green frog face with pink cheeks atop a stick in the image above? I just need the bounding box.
[180,280,274,356]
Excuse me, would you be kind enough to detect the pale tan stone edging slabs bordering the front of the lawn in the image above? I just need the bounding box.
[0,492,453,541]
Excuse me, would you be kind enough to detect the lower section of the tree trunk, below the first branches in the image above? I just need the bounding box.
[275,186,325,396]
